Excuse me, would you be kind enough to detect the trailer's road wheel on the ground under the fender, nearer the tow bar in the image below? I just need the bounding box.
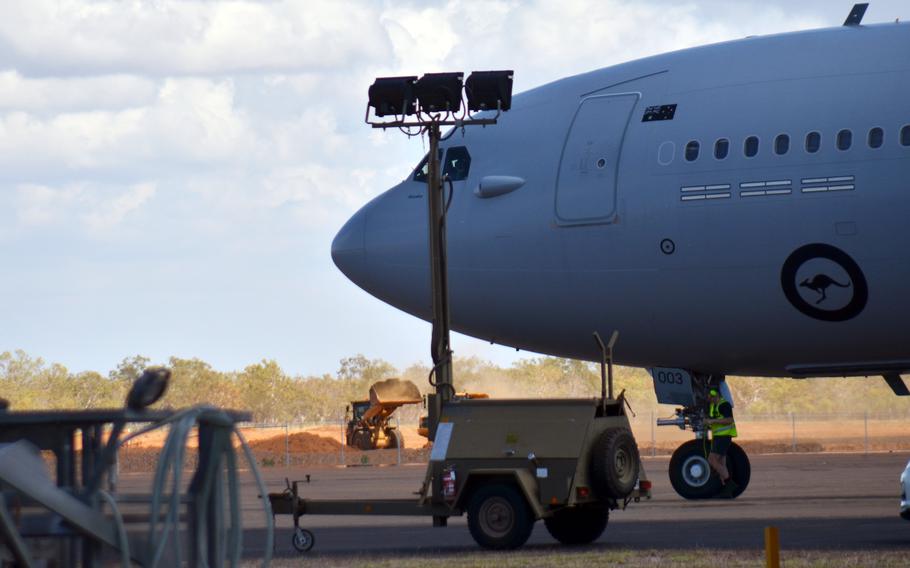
[468,483,534,550]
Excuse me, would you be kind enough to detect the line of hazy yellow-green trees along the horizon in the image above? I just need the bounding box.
[0,351,910,423]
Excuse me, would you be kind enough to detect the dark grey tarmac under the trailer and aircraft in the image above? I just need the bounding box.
[117,453,910,558]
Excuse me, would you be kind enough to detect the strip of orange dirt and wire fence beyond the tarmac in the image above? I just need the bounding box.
[114,410,910,472]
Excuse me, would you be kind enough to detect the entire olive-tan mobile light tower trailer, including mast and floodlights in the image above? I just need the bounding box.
[269,71,650,550]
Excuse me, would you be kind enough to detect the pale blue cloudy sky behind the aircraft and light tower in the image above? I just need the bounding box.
[0,0,910,374]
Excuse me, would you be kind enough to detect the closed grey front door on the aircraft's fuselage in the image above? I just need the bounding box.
[556,93,639,225]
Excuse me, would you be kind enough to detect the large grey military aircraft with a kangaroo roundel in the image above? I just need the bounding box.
[332,5,910,497]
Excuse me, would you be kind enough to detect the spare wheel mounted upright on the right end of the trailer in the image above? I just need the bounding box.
[591,428,639,499]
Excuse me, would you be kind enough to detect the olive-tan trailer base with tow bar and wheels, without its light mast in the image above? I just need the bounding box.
[269,394,650,551]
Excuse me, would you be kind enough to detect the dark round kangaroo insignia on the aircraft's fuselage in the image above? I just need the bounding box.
[780,244,869,321]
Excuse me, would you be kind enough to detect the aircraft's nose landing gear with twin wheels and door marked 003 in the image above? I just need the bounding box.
[650,367,752,499]
